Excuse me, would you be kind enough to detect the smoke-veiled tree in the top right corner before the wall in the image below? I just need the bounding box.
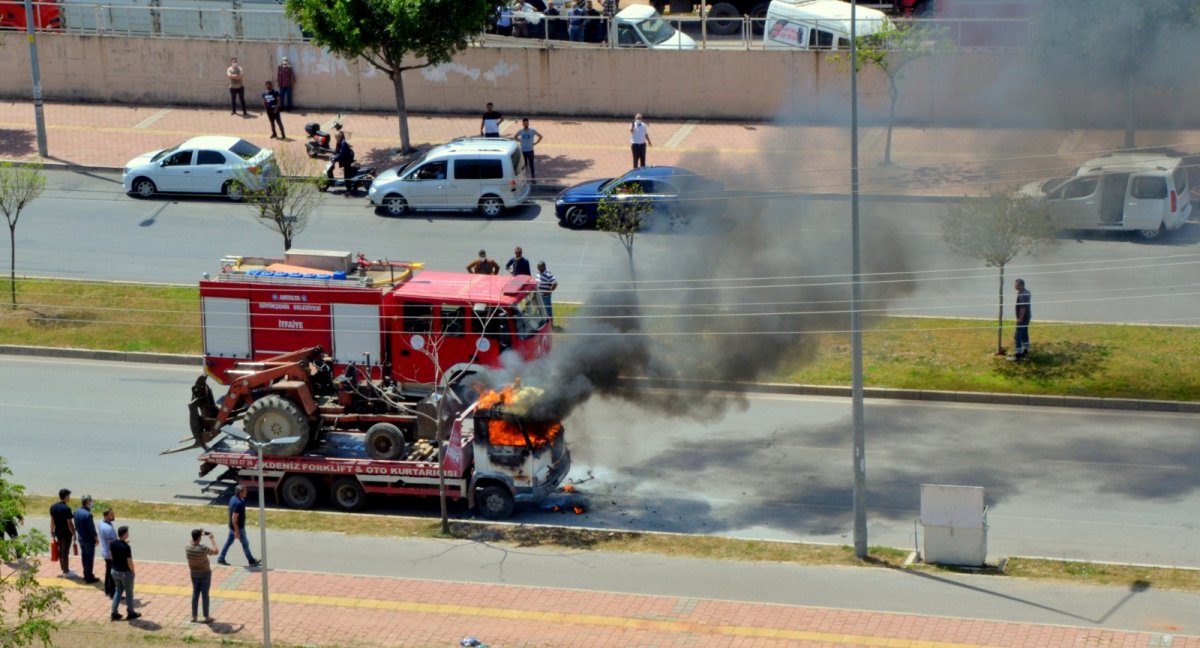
[1031,0,1200,149]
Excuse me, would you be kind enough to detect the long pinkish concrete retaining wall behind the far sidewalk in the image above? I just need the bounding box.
[0,34,1200,128]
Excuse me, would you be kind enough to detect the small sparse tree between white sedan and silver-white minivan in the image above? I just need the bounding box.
[242,149,325,252]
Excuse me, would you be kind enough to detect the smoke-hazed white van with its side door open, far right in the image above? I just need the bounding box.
[1020,154,1192,239]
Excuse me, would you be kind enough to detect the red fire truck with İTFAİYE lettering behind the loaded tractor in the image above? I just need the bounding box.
[200,250,551,385]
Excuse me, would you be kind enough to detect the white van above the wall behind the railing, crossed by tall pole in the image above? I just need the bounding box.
[762,0,892,49]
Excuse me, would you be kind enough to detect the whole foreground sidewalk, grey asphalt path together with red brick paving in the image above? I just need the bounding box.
[7,520,1200,648]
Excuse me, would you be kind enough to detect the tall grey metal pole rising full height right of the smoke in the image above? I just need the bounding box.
[850,0,866,559]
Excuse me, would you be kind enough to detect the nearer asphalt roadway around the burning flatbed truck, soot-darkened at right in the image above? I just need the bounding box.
[0,356,1200,566]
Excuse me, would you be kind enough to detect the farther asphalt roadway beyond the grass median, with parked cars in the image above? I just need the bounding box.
[11,170,1200,324]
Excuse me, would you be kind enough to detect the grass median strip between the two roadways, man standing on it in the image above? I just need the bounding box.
[0,278,1200,401]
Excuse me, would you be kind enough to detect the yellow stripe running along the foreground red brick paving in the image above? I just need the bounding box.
[42,576,1003,648]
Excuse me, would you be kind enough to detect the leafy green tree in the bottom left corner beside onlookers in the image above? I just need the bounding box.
[0,457,67,648]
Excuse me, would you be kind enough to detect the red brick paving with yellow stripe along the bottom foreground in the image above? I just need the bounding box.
[11,560,1200,648]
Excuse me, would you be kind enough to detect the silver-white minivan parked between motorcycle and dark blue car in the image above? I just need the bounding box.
[367,137,529,218]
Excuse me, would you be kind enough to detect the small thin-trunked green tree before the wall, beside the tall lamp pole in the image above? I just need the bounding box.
[830,20,948,166]
